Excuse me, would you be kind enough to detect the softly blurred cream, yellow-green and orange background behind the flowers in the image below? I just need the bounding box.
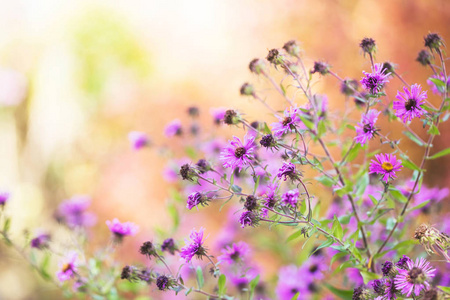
[0,0,450,299]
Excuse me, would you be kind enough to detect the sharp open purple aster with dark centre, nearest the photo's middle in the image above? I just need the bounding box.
[220,135,256,171]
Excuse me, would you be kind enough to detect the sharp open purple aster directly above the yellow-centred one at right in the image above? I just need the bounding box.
[393,84,427,123]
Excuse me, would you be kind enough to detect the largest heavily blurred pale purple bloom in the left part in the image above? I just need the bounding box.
[56,196,97,228]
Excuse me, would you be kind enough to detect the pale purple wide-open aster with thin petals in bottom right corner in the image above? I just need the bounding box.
[394,258,436,297]
